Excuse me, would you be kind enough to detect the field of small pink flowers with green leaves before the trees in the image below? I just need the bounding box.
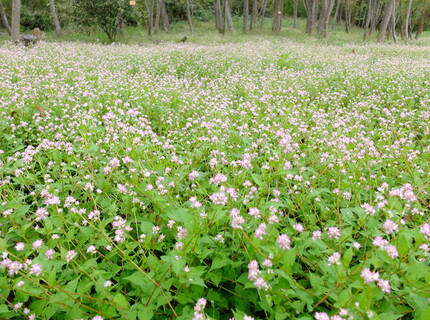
[0,40,430,320]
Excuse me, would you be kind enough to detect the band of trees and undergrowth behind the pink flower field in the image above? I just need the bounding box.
[0,0,430,42]
